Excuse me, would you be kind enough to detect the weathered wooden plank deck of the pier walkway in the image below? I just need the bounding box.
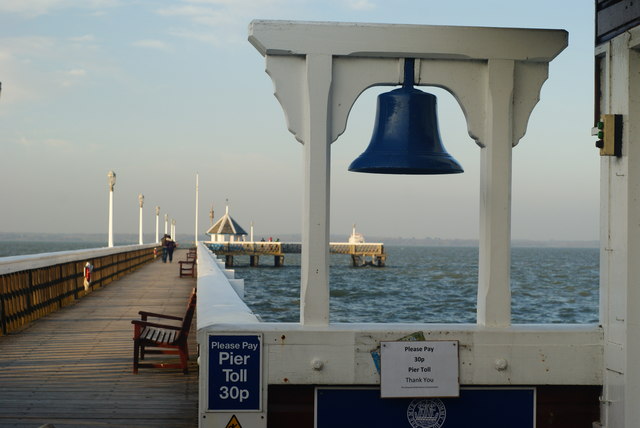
[0,251,198,428]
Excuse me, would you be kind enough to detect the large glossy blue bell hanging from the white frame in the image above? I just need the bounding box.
[349,59,464,174]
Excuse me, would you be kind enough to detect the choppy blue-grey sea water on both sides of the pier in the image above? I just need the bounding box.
[0,241,599,324]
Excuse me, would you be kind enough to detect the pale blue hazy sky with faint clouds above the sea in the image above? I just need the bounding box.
[0,0,600,241]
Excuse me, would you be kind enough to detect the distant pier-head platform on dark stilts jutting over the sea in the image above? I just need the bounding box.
[205,242,387,267]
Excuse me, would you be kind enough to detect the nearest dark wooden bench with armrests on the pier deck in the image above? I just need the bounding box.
[131,288,196,374]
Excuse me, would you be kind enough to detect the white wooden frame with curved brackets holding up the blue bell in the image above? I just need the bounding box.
[249,21,567,327]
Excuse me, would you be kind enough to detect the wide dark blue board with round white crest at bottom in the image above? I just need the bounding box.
[316,387,535,428]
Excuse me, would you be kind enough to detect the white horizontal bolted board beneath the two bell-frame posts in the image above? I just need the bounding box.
[199,322,603,385]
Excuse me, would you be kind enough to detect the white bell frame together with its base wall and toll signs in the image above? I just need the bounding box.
[198,21,604,428]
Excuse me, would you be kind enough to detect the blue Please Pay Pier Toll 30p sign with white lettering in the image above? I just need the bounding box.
[208,335,262,411]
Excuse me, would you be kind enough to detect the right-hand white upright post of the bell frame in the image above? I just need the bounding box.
[477,60,515,327]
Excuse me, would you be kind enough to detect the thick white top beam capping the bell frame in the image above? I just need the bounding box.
[249,20,567,63]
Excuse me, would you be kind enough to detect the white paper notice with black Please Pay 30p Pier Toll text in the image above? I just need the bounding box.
[380,340,460,398]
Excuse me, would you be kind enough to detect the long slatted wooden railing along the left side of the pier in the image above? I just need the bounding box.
[0,244,158,335]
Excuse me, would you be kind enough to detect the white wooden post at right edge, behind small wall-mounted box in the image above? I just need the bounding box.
[594,28,640,428]
